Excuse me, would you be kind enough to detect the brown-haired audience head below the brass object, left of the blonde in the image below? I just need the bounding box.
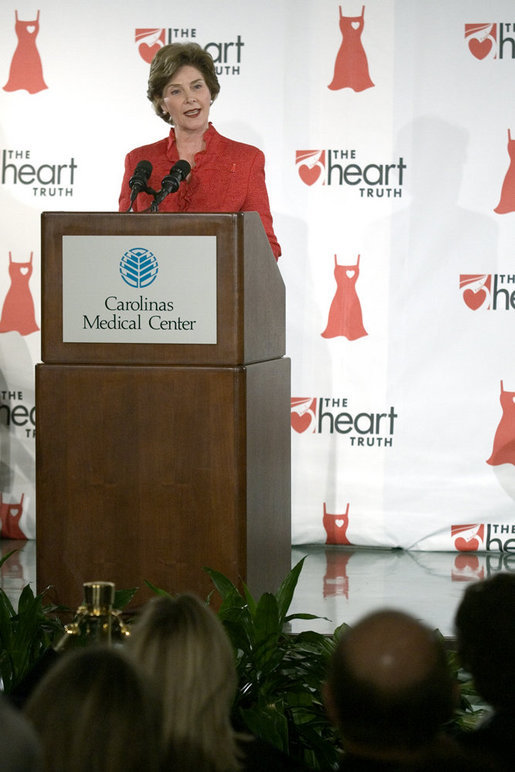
[25,646,162,772]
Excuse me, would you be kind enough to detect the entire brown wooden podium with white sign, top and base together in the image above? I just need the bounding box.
[36,212,291,607]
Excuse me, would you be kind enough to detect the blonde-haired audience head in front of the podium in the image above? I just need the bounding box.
[127,594,243,772]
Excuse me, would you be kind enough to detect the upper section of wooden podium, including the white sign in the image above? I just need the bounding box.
[41,212,285,366]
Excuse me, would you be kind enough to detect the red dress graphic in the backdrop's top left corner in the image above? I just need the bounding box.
[4,11,48,94]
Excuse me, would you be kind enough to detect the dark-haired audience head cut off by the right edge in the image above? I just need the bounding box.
[455,573,515,710]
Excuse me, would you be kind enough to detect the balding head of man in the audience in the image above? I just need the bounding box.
[326,610,455,760]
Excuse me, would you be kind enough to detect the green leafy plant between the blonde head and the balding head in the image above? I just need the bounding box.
[206,558,340,769]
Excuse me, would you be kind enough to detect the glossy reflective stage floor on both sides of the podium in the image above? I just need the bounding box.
[0,540,500,638]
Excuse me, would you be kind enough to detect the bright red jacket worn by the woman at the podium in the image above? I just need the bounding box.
[119,124,281,259]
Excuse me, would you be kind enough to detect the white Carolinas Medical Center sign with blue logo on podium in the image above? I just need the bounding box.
[62,236,217,344]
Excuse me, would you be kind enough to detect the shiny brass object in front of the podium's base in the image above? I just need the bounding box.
[55,582,130,652]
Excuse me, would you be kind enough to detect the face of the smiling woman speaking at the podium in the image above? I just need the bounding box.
[161,64,211,132]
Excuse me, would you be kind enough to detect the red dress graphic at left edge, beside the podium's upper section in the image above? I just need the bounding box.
[0,252,39,335]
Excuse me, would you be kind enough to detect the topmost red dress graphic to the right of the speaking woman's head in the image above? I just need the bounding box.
[328,5,374,91]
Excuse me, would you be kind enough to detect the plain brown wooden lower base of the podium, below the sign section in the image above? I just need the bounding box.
[36,358,291,608]
